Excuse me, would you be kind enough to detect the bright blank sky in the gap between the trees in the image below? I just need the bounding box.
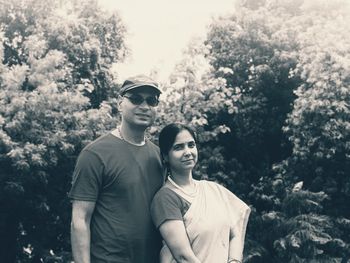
[99,0,235,81]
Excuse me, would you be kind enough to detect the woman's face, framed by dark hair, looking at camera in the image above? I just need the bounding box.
[165,130,198,173]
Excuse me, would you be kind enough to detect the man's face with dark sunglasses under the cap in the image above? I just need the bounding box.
[119,87,158,128]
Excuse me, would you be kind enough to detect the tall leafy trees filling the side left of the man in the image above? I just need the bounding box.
[0,0,125,262]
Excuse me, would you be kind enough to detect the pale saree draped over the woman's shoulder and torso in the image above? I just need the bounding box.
[160,180,250,263]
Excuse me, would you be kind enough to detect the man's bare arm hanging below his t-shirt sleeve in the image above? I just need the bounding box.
[71,200,95,263]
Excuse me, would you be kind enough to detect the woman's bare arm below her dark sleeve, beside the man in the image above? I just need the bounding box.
[159,220,200,263]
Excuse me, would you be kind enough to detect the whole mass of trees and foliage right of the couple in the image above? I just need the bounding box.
[160,1,350,262]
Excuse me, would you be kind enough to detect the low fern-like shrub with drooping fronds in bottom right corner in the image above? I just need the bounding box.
[260,189,350,262]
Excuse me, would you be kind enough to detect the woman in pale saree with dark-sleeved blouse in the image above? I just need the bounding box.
[151,123,250,263]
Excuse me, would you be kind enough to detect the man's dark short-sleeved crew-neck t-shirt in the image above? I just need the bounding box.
[69,134,163,263]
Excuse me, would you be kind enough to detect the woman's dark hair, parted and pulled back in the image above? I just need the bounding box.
[159,123,197,159]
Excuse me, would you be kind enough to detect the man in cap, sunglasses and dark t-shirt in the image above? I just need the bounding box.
[69,75,163,263]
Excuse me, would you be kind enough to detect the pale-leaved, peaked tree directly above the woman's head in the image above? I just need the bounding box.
[154,40,235,141]
